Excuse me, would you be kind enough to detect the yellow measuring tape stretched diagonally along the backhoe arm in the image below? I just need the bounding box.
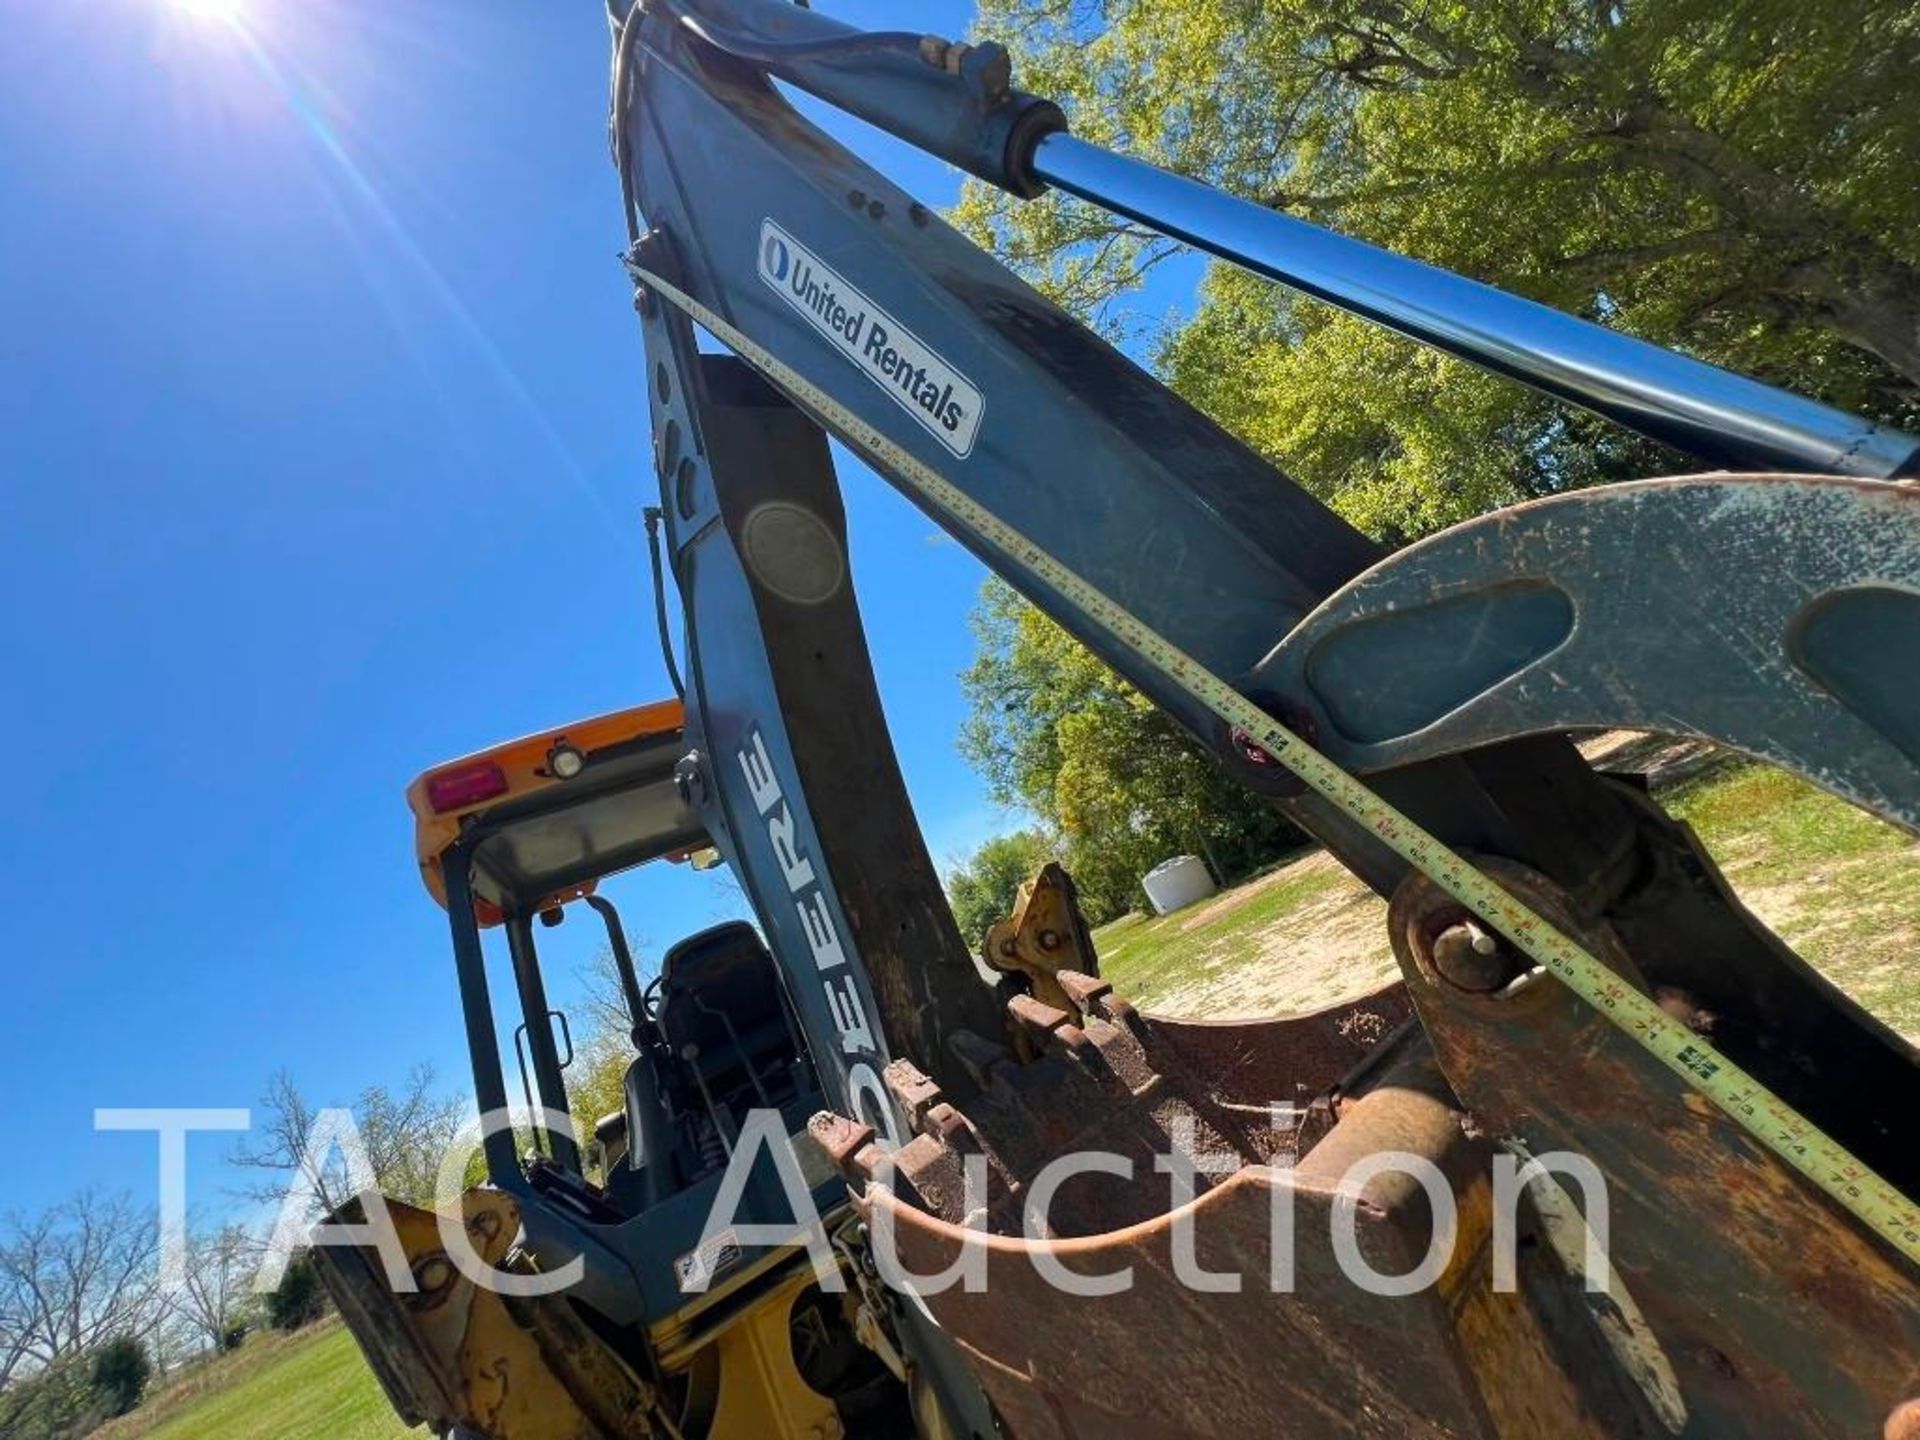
[630,267,1920,1263]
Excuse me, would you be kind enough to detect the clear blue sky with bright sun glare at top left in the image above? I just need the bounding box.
[0,0,1198,1212]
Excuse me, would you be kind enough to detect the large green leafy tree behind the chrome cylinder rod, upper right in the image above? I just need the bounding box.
[958,0,1920,540]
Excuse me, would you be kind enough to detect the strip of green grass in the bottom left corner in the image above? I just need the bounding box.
[96,1323,408,1440]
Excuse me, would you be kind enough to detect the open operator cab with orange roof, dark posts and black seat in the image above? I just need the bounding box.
[407,701,843,1267]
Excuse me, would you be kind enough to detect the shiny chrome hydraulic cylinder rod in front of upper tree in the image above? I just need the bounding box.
[1033,131,1920,478]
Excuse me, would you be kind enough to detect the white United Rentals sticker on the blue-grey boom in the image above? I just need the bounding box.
[760,221,987,459]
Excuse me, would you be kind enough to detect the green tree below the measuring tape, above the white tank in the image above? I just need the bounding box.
[960,580,1300,925]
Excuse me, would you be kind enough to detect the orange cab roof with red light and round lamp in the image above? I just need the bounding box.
[407,701,710,924]
